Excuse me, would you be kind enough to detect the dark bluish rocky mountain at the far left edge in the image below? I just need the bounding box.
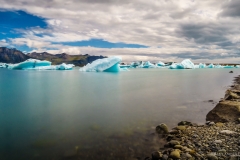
[0,47,29,63]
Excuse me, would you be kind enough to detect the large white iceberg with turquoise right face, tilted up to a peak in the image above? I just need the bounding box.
[79,57,122,72]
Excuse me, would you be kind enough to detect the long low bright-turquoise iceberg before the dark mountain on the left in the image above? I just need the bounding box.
[8,59,51,69]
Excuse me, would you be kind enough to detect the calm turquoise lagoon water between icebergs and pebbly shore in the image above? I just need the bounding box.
[0,69,240,160]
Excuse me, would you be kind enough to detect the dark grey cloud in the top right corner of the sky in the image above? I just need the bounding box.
[220,0,240,17]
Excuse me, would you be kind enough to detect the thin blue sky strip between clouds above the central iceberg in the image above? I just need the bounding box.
[55,39,148,48]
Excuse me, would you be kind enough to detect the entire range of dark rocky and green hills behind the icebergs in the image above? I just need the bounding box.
[0,47,106,66]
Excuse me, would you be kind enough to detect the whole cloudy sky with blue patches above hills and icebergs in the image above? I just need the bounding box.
[0,0,240,63]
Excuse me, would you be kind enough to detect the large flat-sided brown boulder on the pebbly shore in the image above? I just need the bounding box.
[206,100,240,122]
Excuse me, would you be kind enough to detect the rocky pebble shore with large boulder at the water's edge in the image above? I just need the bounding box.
[150,76,240,160]
